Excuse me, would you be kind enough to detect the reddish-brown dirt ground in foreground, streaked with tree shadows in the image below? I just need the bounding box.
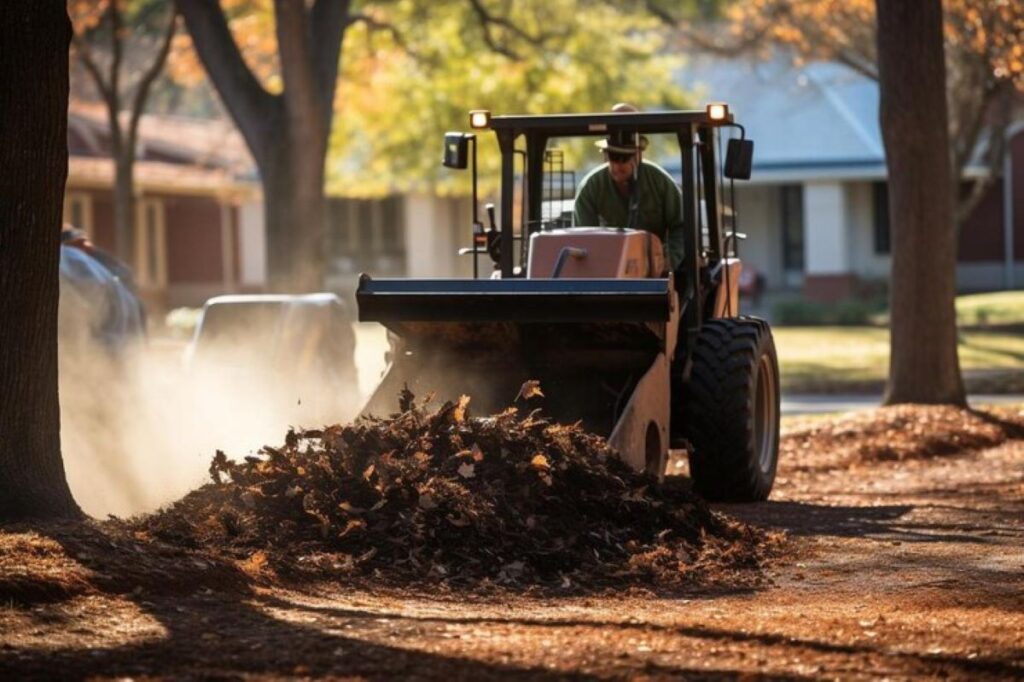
[0,411,1024,680]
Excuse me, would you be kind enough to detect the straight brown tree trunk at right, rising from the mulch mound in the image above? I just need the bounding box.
[877,0,966,404]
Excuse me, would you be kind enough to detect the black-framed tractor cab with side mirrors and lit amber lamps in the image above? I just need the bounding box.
[443,103,753,291]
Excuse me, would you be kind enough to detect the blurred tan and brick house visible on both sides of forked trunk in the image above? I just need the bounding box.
[63,102,472,317]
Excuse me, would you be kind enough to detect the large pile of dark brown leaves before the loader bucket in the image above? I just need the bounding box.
[140,392,771,588]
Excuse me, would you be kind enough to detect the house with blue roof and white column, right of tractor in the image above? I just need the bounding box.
[681,58,1024,301]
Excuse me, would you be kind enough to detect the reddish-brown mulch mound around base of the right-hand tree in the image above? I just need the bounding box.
[779,404,1024,465]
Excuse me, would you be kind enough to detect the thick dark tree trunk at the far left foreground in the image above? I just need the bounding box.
[0,0,81,519]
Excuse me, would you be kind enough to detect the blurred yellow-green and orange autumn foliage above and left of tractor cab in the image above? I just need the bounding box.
[170,0,688,196]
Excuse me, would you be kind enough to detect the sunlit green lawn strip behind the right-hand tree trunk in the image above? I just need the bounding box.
[772,327,1024,390]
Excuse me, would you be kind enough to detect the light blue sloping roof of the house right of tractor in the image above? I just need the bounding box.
[679,55,980,182]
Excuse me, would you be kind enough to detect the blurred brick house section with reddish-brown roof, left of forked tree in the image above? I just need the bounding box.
[63,102,266,312]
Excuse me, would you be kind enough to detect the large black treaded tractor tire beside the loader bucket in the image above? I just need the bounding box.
[672,317,779,502]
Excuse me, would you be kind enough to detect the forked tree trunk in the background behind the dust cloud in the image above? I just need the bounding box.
[175,0,349,292]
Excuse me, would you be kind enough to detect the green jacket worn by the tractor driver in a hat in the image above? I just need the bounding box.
[572,161,685,270]
